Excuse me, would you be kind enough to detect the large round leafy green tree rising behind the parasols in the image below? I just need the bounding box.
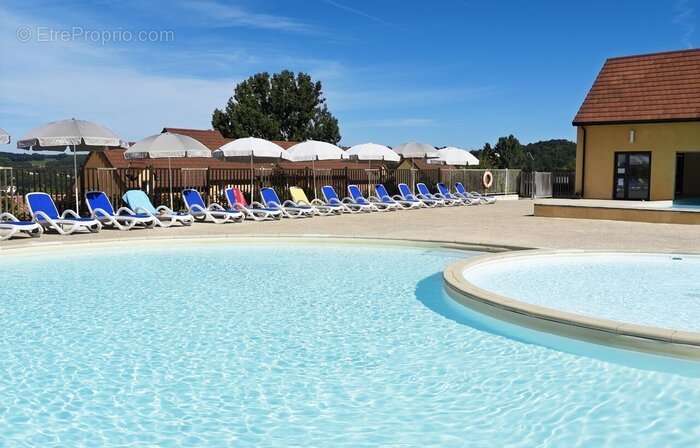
[212,70,340,143]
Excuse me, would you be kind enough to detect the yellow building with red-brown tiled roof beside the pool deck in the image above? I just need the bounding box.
[573,49,700,201]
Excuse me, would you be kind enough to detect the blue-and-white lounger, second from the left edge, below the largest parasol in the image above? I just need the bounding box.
[25,192,102,235]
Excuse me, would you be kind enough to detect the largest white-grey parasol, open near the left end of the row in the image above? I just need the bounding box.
[17,118,129,211]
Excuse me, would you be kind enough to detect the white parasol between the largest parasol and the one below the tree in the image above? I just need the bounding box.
[124,132,211,208]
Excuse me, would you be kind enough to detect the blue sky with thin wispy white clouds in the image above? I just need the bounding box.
[0,0,700,149]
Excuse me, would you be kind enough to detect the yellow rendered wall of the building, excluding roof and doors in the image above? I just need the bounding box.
[576,121,700,201]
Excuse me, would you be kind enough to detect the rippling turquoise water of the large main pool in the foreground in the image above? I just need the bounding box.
[0,242,700,448]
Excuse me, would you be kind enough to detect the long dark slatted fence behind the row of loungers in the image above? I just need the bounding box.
[0,168,520,216]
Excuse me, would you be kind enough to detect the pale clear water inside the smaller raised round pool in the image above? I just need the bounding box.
[465,254,700,331]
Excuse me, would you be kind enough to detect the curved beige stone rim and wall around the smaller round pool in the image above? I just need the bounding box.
[443,250,700,360]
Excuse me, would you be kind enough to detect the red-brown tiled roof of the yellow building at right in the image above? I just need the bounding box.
[573,49,700,126]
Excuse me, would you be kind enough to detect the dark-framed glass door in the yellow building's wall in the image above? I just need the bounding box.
[613,152,651,201]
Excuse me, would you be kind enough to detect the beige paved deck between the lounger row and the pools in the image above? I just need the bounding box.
[0,200,700,253]
